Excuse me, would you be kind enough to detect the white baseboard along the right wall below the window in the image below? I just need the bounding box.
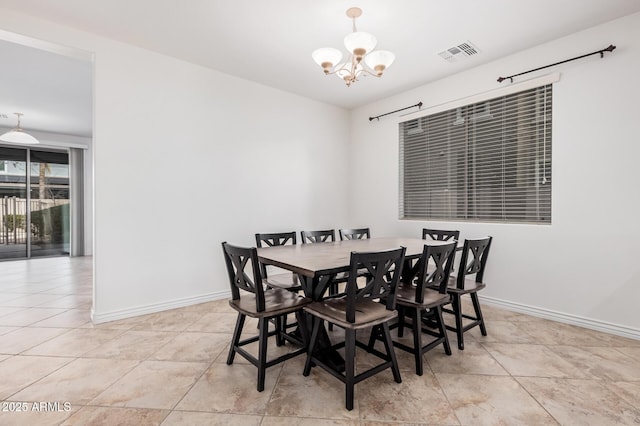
[478,295,640,340]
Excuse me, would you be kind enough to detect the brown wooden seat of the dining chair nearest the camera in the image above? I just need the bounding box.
[304,297,398,330]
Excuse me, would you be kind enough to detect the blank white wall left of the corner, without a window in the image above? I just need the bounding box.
[0,11,349,322]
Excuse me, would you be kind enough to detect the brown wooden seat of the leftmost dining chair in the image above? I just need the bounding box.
[229,288,311,318]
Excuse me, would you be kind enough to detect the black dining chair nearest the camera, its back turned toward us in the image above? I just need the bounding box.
[303,247,406,410]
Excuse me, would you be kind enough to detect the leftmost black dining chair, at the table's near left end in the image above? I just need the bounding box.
[222,242,311,392]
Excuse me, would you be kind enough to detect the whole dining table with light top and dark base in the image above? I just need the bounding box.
[258,237,450,370]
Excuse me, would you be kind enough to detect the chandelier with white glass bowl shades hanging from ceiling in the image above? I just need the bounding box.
[311,7,395,87]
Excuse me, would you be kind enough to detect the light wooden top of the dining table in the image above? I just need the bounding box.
[258,237,448,278]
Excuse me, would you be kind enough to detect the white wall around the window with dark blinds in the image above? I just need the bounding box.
[349,14,640,338]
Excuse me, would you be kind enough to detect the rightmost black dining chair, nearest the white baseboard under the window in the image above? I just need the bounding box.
[442,237,493,350]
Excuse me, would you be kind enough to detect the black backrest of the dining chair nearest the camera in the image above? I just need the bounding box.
[346,247,406,323]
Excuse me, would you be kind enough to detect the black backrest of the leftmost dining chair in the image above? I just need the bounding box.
[222,241,265,312]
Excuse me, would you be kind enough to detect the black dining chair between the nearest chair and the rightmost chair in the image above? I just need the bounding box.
[369,241,457,376]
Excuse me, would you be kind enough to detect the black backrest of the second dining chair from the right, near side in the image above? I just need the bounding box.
[415,241,458,303]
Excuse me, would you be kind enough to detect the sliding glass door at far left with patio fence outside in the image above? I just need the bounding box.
[0,147,70,260]
